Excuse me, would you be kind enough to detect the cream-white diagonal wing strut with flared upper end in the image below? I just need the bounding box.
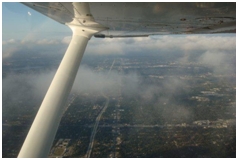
[18,20,105,158]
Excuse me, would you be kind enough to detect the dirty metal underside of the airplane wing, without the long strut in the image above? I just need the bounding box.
[23,2,236,38]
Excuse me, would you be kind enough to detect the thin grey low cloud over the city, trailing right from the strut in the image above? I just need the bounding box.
[2,65,192,120]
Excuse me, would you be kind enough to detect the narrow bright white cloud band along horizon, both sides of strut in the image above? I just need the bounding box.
[2,34,236,62]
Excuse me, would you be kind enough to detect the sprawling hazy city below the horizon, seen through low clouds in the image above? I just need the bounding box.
[2,51,236,158]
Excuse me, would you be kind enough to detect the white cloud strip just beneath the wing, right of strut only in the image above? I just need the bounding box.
[87,35,236,55]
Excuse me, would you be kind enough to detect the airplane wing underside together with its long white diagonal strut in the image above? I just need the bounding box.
[18,2,236,157]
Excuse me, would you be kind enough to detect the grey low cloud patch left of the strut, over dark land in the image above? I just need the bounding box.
[2,71,55,102]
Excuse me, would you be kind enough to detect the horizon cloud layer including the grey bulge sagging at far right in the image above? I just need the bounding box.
[2,34,236,75]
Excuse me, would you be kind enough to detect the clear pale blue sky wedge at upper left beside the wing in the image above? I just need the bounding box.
[2,2,71,40]
